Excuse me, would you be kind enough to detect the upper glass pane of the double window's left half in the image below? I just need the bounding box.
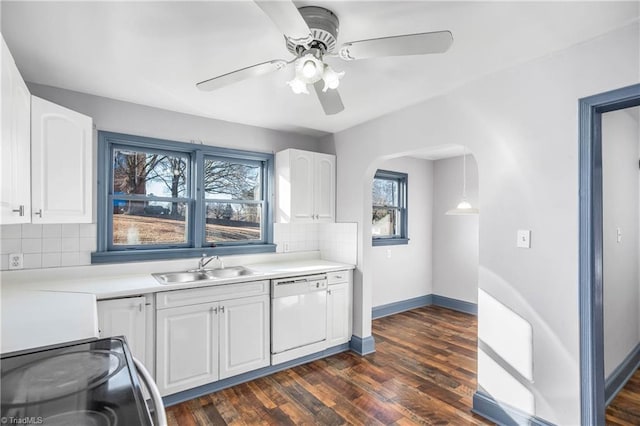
[113,149,189,198]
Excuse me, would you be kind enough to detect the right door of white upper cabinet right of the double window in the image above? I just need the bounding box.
[313,154,336,222]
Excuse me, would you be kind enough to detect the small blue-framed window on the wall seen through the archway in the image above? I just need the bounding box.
[371,170,409,246]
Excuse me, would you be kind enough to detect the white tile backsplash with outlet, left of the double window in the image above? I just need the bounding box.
[0,223,97,270]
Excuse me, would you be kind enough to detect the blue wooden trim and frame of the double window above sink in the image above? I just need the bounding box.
[91,131,276,263]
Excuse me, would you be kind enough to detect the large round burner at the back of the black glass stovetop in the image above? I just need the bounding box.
[1,349,124,406]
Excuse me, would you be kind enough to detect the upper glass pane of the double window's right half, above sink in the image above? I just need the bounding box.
[204,159,262,200]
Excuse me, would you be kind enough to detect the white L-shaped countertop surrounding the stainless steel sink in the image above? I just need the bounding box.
[0,253,354,353]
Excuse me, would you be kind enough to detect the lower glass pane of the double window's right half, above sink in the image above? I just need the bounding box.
[205,202,262,244]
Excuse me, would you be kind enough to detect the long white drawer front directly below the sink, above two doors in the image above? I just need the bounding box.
[156,280,269,309]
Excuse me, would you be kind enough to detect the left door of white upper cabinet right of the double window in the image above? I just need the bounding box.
[289,149,315,222]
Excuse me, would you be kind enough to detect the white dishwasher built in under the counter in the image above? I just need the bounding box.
[271,274,327,365]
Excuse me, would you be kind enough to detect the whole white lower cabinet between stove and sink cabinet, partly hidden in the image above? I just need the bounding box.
[98,295,154,375]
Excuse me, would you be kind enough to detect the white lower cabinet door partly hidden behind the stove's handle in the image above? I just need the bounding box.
[98,296,149,362]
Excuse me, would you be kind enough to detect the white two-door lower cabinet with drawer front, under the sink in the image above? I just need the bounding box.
[156,281,270,396]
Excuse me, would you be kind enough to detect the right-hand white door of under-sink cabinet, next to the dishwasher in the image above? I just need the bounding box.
[220,295,270,379]
